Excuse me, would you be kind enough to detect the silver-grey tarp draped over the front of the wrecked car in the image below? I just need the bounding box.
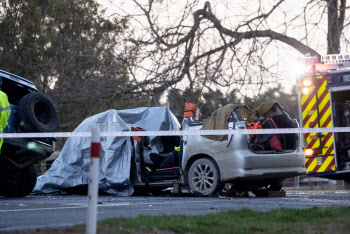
[34,107,180,196]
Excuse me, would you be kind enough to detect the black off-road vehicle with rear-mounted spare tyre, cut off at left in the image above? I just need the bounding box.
[0,70,59,197]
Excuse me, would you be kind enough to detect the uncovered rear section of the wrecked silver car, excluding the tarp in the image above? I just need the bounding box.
[131,101,306,196]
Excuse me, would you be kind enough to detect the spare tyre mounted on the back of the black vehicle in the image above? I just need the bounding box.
[17,92,60,132]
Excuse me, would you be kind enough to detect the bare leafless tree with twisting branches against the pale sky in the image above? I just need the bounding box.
[111,0,350,104]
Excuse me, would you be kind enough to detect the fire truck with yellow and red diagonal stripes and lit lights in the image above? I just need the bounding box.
[298,54,350,189]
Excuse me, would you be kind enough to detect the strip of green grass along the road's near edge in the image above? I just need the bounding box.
[13,207,350,234]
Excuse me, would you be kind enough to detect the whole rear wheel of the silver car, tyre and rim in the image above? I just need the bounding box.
[187,158,220,196]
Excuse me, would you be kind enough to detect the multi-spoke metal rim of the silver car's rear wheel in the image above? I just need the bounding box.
[192,163,215,193]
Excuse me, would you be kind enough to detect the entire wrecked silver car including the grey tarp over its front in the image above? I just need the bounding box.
[34,102,306,196]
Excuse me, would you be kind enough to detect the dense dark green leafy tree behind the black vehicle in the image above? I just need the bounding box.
[0,0,130,130]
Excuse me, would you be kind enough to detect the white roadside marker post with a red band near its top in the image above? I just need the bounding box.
[86,126,100,234]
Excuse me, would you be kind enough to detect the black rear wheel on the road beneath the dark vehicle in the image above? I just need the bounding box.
[0,165,37,197]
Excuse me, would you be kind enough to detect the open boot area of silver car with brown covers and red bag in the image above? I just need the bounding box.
[198,101,300,154]
